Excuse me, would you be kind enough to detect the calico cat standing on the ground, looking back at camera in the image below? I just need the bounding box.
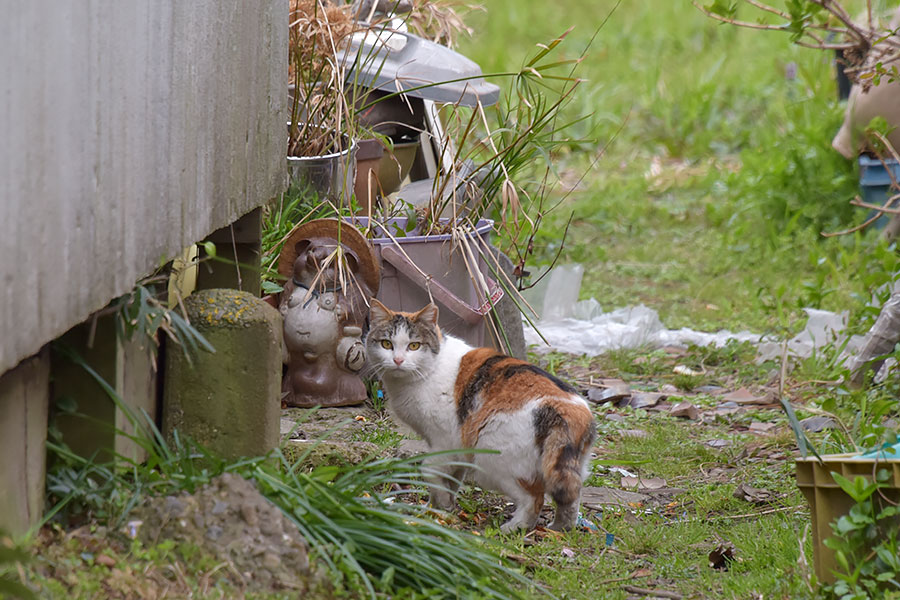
[366,299,596,532]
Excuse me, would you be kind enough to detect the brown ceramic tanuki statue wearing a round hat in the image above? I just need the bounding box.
[278,219,381,408]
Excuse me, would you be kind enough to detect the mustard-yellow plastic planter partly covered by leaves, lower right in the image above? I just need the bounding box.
[797,454,900,583]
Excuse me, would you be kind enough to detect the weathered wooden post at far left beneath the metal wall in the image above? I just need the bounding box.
[0,349,50,535]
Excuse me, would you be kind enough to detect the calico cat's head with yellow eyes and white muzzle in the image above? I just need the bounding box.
[366,298,441,379]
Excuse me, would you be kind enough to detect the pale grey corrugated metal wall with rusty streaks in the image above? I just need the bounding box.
[0,0,288,374]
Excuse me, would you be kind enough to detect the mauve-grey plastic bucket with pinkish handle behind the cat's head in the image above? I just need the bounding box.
[349,217,503,347]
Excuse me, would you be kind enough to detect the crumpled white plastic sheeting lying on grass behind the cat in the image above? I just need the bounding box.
[524,265,862,360]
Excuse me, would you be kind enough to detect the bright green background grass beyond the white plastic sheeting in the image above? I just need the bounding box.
[462,0,897,332]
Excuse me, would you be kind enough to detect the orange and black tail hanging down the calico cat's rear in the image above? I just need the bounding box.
[541,420,597,506]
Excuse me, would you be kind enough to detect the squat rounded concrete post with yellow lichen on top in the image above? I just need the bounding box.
[163,289,282,458]
